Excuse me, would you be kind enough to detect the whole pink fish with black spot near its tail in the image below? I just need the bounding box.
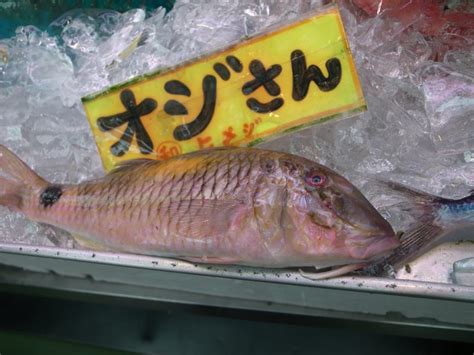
[0,146,399,275]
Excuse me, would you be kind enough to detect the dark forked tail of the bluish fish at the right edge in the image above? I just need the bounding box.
[363,181,474,276]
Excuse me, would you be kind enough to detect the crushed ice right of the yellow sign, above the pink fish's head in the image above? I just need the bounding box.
[265,2,474,234]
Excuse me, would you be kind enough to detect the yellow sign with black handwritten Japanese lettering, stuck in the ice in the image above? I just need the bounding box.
[83,7,366,170]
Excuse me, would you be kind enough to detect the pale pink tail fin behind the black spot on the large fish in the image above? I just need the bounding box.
[0,145,47,211]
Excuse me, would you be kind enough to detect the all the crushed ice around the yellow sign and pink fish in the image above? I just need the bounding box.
[0,0,474,280]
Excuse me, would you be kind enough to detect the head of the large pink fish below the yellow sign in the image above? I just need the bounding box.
[287,161,399,262]
